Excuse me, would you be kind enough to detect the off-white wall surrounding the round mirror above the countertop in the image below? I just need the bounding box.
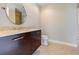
[0,3,40,27]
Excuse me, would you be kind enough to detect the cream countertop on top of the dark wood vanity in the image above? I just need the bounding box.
[0,29,40,37]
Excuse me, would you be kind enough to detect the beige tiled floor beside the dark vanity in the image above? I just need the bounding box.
[33,43,79,55]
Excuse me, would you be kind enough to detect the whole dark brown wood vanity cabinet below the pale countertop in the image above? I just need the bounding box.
[0,30,41,55]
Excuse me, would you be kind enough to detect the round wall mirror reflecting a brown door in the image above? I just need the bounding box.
[5,3,26,25]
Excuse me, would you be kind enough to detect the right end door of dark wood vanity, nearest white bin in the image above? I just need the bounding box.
[30,30,41,52]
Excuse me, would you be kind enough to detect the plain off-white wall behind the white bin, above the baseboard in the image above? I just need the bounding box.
[41,4,77,44]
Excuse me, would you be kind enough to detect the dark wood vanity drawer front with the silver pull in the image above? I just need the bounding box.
[0,34,31,55]
